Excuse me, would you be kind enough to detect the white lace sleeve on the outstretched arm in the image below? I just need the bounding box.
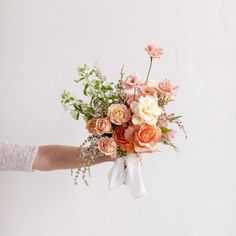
[0,141,38,171]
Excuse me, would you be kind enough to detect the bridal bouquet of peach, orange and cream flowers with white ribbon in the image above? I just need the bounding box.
[61,44,186,196]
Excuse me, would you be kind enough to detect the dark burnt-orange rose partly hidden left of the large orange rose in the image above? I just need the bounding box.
[113,126,134,153]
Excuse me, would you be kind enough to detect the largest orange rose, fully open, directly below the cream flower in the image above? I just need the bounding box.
[133,124,162,152]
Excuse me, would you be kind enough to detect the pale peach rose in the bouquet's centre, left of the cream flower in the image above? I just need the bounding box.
[107,104,131,125]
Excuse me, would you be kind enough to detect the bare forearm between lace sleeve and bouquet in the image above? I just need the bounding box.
[32,145,115,171]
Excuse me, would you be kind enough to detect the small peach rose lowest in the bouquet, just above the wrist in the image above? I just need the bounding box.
[98,137,117,157]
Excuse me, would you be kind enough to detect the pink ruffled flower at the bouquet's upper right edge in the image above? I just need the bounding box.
[156,79,179,100]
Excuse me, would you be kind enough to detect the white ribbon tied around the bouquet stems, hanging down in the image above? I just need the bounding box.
[108,154,147,198]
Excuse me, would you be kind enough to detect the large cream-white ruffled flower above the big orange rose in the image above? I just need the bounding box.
[130,95,162,125]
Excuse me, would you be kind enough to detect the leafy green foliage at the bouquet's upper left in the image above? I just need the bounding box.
[61,64,127,120]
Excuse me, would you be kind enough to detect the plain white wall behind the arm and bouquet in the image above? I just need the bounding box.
[0,0,236,236]
